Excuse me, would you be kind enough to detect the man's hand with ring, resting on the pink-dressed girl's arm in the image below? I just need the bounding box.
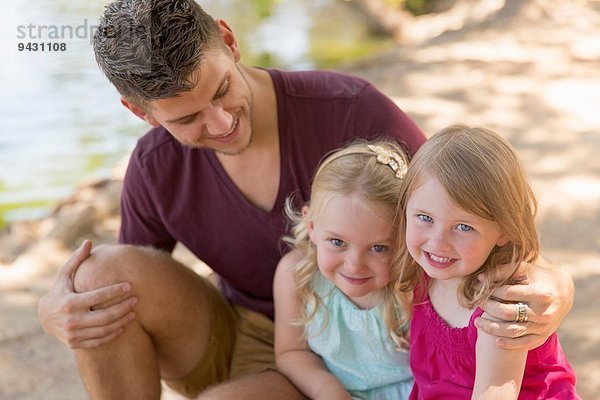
[475,258,574,350]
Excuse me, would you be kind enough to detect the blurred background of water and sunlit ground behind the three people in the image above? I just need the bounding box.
[0,0,600,400]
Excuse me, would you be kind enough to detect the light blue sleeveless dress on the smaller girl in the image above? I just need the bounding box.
[307,274,413,400]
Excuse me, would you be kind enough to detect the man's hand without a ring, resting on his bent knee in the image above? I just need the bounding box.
[38,240,137,349]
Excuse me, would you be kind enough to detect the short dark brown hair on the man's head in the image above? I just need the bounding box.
[94,0,219,108]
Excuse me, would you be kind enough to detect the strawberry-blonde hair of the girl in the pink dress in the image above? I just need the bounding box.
[394,125,540,309]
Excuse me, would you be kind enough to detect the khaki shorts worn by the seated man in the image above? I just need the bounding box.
[165,281,275,398]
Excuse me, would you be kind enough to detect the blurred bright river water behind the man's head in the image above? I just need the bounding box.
[0,0,393,226]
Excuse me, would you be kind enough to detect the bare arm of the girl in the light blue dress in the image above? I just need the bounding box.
[273,250,351,400]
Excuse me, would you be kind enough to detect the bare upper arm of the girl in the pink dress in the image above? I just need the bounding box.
[472,313,527,400]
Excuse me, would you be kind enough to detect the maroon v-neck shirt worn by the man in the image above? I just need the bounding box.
[119,69,425,318]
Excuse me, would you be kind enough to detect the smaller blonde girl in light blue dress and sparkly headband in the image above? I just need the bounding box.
[274,141,412,400]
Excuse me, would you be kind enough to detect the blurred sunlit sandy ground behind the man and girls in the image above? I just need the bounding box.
[0,0,600,400]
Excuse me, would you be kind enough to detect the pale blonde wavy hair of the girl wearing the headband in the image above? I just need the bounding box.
[284,139,408,348]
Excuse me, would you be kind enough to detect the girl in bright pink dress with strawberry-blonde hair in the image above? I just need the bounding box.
[398,125,579,400]
